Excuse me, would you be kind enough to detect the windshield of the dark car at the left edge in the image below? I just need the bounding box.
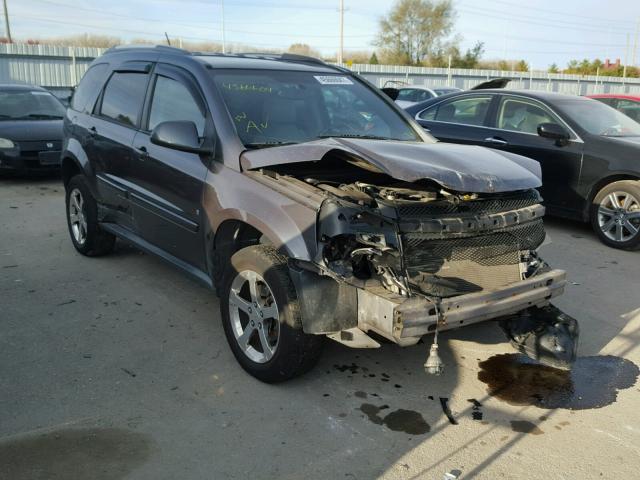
[0,90,65,120]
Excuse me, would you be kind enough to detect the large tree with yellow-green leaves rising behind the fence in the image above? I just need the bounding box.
[375,0,454,65]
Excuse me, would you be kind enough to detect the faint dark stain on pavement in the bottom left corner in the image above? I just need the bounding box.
[0,428,153,480]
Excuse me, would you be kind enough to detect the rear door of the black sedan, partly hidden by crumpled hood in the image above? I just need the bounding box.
[416,94,495,145]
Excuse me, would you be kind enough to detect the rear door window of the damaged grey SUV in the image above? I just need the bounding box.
[100,72,149,127]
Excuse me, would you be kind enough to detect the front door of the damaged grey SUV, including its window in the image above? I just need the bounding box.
[126,64,213,270]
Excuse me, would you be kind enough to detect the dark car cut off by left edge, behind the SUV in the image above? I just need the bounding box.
[0,85,65,173]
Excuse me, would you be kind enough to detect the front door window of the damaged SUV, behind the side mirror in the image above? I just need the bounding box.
[149,76,205,137]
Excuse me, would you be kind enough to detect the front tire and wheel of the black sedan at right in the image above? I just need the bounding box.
[591,180,640,250]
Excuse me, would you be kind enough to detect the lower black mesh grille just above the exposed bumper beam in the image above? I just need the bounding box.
[402,219,545,297]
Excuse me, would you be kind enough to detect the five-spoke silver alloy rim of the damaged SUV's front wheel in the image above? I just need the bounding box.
[229,270,280,363]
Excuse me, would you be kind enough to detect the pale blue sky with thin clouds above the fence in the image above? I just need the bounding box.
[7,0,640,69]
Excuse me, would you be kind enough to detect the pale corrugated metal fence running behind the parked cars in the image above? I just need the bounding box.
[0,44,640,95]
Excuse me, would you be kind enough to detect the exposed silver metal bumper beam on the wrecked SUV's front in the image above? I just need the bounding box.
[358,270,566,345]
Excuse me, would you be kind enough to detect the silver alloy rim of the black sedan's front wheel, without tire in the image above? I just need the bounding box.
[598,191,640,242]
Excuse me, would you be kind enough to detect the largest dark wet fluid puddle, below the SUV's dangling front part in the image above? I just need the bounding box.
[478,353,640,410]
